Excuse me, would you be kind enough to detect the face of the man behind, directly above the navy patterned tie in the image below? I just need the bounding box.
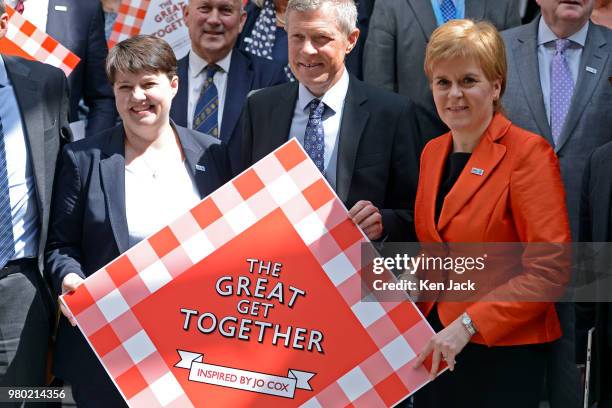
[184,0,246,63]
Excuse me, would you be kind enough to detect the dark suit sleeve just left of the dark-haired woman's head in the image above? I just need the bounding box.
[81,5,117,136]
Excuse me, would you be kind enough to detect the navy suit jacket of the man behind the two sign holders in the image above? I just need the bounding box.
[170,49,287,173]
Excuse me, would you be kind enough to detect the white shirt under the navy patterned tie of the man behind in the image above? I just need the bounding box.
[187,49,233,131]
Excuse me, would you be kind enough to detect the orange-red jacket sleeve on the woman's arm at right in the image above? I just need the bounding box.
[467,137,571,345]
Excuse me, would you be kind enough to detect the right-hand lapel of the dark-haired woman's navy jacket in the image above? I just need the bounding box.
[174,127,216,198]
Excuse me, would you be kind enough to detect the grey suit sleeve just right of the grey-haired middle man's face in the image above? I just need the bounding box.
[363,0,396,92]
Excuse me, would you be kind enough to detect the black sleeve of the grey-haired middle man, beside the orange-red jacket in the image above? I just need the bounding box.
[381,101,422,242]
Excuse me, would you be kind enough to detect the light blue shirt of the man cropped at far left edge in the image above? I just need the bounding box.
[0,57,43,259]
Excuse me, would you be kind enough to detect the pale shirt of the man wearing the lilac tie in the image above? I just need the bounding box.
[538,18,589,124]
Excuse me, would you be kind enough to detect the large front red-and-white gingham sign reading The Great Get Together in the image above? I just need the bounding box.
[62,139,433,408]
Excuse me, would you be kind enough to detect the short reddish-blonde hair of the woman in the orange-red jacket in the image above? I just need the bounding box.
[425,20,508,109]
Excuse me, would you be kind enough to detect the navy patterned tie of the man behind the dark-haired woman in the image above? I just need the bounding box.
[193,64,221,138]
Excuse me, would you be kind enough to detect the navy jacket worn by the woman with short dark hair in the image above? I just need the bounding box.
[45,126,229,382]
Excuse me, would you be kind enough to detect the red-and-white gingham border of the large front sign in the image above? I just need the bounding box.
[63,139,433,407]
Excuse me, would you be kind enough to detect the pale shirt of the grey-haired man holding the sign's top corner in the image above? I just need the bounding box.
[289,68,349,190]
